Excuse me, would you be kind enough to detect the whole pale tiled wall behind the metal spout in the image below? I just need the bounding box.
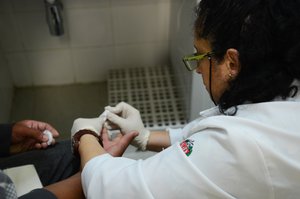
[0,0,172,87]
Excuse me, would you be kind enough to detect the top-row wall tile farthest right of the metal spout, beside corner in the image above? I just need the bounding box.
[112,3,169,44]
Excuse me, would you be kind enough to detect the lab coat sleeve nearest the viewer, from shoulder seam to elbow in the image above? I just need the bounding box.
[82,140,239,199]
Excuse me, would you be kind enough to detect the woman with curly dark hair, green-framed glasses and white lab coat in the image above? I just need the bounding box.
[73,0,300,199]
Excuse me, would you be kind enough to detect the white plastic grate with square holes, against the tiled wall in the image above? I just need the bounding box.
[108,66,186,130]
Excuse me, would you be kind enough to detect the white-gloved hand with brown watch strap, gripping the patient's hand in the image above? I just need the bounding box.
[71,111,107,154]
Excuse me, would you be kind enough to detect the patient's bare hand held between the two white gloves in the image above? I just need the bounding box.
[101,128,138,157]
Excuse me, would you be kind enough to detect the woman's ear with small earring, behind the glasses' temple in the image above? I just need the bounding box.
[225,48,240,78]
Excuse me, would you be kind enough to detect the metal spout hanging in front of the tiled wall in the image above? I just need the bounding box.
[44,0,64,36]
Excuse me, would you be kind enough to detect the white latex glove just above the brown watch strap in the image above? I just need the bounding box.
[71,111,108,137]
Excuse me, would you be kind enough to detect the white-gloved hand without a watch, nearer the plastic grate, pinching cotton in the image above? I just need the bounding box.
[105,102,150,151]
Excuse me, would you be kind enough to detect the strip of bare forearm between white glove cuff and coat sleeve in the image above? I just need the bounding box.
[147,131,171,151]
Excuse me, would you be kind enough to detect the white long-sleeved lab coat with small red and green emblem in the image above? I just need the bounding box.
[82,90,300,199]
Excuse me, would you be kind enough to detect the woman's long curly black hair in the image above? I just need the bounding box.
[195,0,300,113]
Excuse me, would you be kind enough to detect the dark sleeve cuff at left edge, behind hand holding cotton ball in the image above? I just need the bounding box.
[0,124,13,157]
